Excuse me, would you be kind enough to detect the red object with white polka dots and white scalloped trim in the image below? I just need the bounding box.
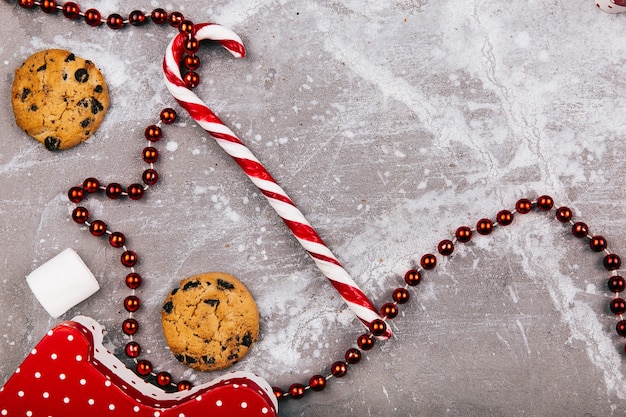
[0,317,278,417]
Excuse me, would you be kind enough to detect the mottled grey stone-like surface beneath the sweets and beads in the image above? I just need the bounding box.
[0,0,626,416]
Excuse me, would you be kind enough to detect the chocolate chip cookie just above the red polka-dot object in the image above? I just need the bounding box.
[161,272,259,371]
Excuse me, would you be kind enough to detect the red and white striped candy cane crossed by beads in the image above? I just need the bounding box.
[163,23,392,339]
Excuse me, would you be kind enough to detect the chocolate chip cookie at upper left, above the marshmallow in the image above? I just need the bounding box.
[12,49,109,151]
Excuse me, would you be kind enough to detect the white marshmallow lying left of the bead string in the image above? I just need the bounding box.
[26,248,100,318]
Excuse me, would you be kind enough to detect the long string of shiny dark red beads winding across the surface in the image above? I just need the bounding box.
[11,0,626,399]
